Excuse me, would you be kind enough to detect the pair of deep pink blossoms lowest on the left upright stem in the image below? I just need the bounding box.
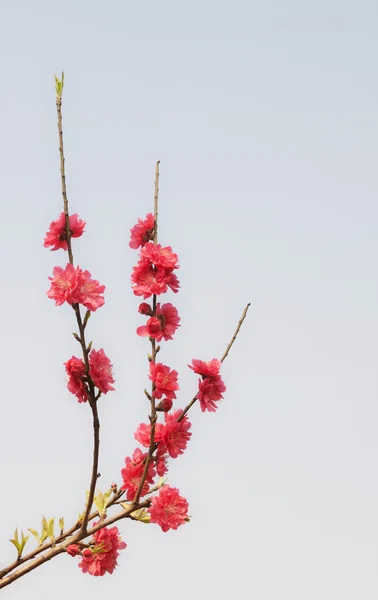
[64,348,114,402]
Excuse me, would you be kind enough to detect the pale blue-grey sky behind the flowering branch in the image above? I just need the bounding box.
[0,0,378,600]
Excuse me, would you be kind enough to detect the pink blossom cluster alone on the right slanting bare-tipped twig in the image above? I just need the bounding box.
[188,358,226,412]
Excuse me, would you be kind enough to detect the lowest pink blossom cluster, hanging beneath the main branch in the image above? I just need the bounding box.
[77,523,126,577]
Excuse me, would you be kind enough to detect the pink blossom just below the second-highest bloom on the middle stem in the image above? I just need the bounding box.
[131,261,180,299]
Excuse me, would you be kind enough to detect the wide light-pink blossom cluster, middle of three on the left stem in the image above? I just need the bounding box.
[47,263,105,311]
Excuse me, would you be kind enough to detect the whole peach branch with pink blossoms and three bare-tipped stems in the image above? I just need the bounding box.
[0,74,249,588]
